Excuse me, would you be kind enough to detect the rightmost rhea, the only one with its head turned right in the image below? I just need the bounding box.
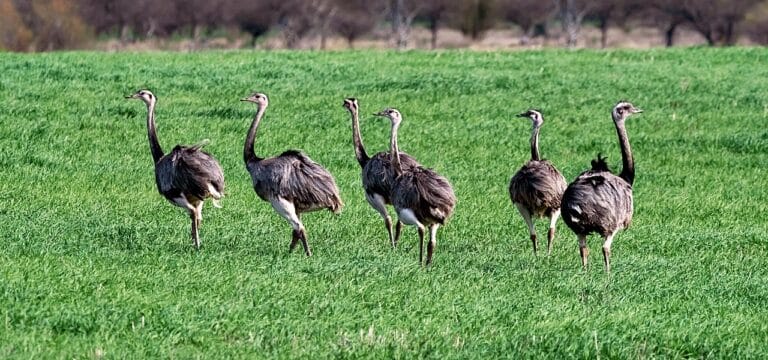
[562,101,642,272]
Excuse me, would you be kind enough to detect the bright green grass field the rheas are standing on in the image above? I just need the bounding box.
[0,48,768,359]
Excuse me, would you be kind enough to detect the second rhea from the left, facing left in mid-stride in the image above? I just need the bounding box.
[241,93,343,256]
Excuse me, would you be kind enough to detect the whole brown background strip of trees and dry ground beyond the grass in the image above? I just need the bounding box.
[0,0,768,51]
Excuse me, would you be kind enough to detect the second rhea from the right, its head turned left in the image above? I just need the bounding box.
[509,110,567,255]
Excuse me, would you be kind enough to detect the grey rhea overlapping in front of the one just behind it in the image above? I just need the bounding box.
[374,108,456,266]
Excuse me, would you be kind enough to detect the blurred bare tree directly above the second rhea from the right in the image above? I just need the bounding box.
[499,0,557,45]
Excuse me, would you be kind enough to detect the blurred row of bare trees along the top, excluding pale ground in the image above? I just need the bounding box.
[0,0,768,51]
